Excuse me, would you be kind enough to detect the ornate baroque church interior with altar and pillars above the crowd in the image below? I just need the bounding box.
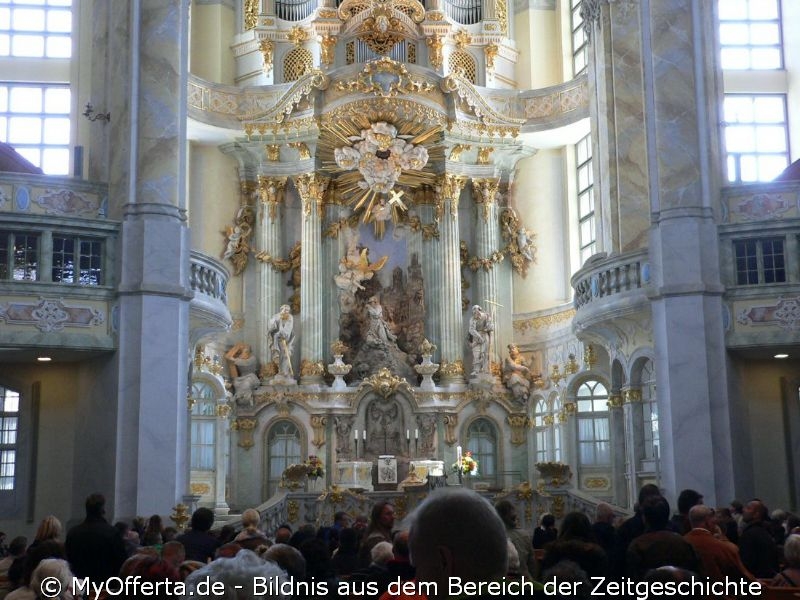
[0,0,800,533]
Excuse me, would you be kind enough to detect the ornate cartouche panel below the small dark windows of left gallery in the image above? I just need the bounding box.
[0,298,105,333]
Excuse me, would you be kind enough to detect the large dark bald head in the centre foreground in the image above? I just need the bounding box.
[409,487,508,600]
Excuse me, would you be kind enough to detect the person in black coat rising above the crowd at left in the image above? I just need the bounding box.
[64,494,127,582]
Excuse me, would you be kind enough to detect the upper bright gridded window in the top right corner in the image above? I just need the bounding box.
[719,0,783,69]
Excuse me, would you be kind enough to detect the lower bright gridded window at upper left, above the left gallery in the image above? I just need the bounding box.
[0,83,70,175]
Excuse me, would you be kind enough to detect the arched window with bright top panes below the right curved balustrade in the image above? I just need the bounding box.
[577,380,611,466]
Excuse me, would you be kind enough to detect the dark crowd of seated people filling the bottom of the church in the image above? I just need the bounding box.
[0,485,800,600]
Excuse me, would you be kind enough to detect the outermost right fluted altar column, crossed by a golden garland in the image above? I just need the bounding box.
[472,177,503,364]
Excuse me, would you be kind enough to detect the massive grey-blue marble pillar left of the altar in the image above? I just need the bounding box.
[104,0,192,518]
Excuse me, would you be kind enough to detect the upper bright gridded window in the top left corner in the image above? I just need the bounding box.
[0,0,72,58]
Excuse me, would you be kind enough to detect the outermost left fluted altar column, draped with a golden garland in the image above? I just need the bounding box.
[256,175,286,377]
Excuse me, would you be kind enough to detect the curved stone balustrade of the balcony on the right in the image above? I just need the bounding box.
[572,250,650,309]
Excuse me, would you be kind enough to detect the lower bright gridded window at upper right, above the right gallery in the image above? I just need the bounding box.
[723,94,789,183]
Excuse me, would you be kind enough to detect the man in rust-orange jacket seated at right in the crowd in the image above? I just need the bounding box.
[683,504,755,581]
